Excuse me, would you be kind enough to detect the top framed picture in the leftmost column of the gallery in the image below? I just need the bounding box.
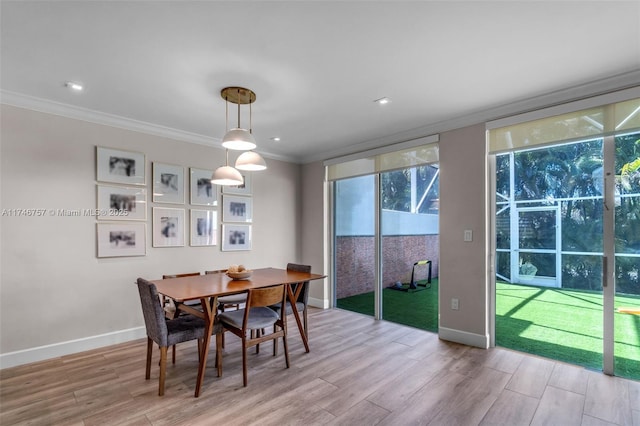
[96,146,146,185]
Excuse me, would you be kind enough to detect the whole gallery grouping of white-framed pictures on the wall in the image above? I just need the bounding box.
[95,146,253,257]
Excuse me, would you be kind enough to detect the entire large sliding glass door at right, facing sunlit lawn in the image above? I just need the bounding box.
[488,99,640,380]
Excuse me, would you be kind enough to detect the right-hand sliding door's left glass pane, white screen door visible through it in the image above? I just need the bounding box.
[495,139,604,368]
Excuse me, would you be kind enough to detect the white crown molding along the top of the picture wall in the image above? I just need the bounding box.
[0,90,296,162]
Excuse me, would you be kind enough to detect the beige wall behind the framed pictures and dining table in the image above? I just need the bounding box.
[0,105,302,367]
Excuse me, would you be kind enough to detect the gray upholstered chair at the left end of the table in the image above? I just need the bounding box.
[137,278,222,396]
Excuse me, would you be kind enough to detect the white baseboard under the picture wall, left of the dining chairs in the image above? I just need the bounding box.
[0,327,147,369]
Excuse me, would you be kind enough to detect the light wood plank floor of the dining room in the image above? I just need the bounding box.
[0,310,640,426]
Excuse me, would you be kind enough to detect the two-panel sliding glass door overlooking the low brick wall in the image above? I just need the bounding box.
[333,161,439,331]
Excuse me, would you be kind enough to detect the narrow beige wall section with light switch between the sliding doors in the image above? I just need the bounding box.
[439,124,489,347]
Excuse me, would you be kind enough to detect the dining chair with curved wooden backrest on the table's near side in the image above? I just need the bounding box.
[216,284,289,387]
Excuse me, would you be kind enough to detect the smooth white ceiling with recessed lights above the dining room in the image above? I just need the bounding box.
[0,0,640,163]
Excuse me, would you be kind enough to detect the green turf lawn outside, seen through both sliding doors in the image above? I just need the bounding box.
[337,279,640,380]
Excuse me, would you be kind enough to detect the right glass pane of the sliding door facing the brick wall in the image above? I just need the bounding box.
[380,164,440,331]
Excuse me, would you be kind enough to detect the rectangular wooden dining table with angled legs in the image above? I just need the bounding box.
[151,268,326,397]
